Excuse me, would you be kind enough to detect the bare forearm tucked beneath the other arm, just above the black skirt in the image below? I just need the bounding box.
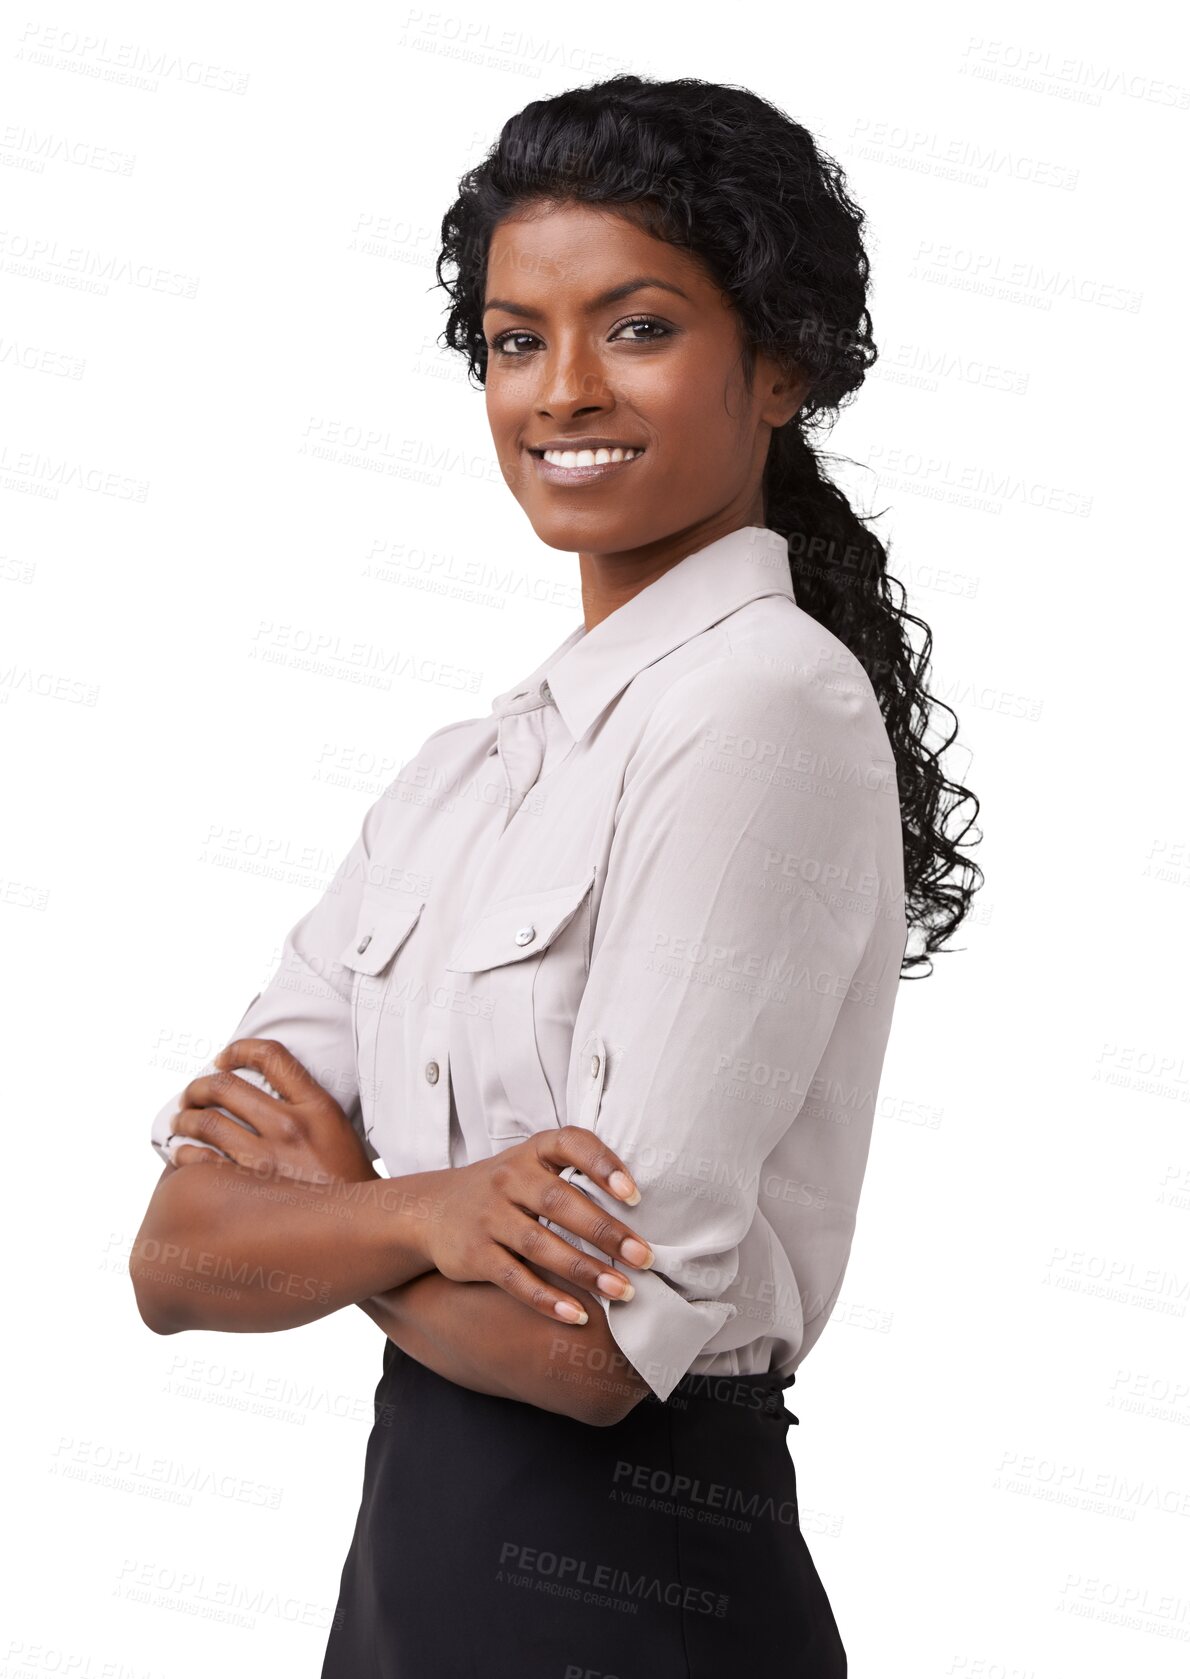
[359,1266,648,1425]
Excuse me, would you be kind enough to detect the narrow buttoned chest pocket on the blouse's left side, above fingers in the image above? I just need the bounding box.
[339,888,425,1138]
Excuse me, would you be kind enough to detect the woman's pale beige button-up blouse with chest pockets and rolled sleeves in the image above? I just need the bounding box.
[153,526,906,1399]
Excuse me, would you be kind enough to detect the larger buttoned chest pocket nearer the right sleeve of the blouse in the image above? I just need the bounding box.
[446,868,594,1145]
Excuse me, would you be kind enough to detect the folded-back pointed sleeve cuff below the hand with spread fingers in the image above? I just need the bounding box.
[547,1167,737,1400]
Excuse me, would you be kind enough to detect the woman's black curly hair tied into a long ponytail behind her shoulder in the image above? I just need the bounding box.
[436,74,984,977]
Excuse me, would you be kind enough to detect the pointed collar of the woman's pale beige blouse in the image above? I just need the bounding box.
[492,526,796,740]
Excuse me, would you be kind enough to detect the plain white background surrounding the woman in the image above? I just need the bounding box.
[0,0,1190,1679]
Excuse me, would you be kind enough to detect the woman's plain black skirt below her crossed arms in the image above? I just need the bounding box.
[322,1340,848,1679]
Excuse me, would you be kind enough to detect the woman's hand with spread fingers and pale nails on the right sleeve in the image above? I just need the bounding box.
[426,1125,653,1323]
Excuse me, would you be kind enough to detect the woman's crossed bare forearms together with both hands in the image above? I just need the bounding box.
[138,1039,651,1425]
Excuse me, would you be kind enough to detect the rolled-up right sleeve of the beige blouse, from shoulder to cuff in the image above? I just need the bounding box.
[551,653,900,1400]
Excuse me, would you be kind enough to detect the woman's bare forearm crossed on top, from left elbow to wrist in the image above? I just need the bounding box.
[129,1160,440,1335]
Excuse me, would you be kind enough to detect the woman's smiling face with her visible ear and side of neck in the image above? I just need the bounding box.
[483,205,807,554]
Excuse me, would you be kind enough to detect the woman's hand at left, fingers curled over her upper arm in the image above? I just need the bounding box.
[171,1038,379,1184]
